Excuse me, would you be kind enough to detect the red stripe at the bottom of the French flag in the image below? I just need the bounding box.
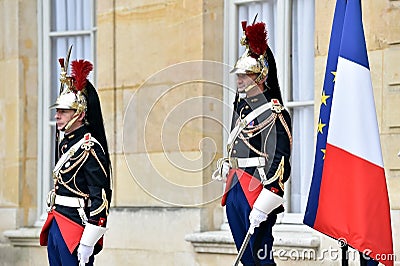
[314,143,393,265]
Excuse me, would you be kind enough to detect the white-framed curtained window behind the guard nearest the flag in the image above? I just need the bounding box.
[224,0,314,219]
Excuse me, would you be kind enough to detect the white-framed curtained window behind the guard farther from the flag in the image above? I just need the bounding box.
[37,0,96,223]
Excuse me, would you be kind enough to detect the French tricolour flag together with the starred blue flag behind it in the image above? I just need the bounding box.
[304,0,394,265]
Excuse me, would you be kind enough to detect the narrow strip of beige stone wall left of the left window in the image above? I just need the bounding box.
[0,1,38,239]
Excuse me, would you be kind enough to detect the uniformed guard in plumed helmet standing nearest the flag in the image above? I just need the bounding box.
[213,19,292,266]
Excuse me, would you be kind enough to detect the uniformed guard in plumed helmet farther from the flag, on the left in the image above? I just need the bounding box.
[40,54,112,265]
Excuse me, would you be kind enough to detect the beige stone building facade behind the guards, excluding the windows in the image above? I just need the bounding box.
[0,0,400,266]
